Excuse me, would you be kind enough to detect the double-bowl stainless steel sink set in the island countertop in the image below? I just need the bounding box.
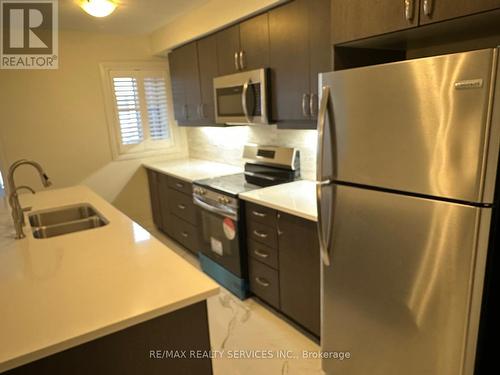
[29,204,109,239]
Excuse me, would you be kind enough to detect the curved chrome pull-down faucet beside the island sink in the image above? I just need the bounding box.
[7,159,52,239]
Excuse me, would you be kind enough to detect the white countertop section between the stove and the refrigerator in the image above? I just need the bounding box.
[239,180,318,221]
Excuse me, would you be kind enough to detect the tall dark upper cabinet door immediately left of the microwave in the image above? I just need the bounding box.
[197,35,218,123]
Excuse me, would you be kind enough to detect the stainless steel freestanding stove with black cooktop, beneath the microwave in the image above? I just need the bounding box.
[193,145,300,298]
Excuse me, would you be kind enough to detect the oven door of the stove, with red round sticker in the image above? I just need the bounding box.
[193,196,246,278]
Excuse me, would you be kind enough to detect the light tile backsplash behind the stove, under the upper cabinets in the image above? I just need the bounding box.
[186,125,318,180]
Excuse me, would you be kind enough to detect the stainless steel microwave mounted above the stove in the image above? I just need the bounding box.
[214,69,269,125]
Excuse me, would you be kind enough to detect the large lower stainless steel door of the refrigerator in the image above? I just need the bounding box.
[321,185,491,375]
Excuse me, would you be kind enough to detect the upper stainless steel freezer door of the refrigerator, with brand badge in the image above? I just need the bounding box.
[320,49,500,203]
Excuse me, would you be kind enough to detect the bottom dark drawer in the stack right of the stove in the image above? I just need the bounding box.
[248,259,280,309]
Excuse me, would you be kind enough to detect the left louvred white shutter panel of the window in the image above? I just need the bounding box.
[113,77,144,145]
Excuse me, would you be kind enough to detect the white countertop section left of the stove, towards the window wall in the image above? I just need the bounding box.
[143,159,243,182]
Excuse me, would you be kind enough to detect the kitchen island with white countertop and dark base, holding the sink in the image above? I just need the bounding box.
[0,186,219,374]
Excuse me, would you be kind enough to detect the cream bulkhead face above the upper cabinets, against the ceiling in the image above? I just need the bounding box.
[151,0,289,54]
